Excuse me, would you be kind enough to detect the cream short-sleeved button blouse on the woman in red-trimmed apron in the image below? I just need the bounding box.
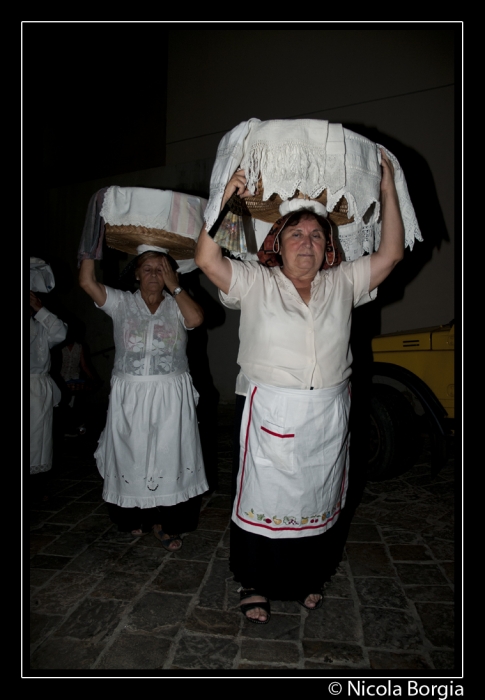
[219,256,377,393]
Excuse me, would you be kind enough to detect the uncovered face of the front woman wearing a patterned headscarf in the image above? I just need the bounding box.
[280,215,326,274]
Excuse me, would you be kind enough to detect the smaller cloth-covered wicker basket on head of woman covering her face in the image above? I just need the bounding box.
[100,185,207,272]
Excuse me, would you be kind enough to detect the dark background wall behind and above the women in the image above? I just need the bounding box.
[23,22,461,400]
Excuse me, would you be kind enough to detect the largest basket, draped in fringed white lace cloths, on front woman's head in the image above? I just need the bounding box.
[204,119,422,260]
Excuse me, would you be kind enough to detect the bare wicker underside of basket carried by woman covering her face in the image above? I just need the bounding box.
[105,224,196,260]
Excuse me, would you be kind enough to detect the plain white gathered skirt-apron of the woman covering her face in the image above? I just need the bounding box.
[94,372,209,508]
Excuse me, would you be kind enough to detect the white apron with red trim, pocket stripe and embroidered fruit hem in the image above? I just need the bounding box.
[232,380,350,538]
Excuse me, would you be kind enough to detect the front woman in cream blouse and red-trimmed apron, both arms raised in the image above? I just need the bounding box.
[195,151,404,624]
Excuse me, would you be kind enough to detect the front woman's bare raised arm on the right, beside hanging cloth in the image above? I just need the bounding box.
[369,149,404,292]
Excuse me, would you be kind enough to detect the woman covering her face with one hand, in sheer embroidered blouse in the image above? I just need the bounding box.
[79,245,208,551]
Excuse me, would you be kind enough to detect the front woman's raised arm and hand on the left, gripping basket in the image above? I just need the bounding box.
[195,170,251,294]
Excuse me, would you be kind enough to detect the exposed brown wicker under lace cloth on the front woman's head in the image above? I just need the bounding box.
[228,179,354,226]
